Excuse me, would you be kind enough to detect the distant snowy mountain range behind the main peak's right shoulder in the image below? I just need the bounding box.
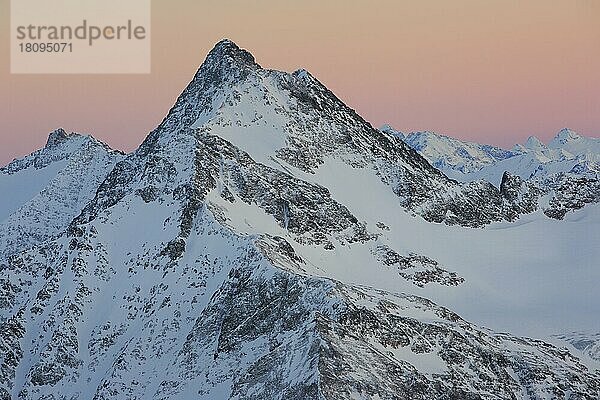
[381,125,600,219]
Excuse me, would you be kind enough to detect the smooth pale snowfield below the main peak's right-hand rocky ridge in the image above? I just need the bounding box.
[220,118,600,337]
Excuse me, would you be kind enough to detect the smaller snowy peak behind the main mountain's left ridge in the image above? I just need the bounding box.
[0,129,123,260]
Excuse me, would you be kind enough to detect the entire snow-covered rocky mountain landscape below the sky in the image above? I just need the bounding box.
[0,40,600,400]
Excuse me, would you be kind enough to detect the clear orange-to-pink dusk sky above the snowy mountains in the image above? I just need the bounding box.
[0,0,600,165]
